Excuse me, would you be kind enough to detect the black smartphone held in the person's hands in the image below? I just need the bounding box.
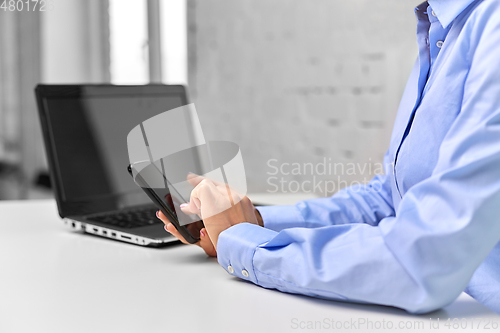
[127,165,205,244]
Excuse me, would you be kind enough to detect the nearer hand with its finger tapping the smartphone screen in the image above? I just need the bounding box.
[180,173,263,251]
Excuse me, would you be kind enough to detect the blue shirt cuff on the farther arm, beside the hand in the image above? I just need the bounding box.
[256,205,305,231]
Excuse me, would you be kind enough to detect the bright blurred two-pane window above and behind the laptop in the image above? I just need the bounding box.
[109,0,187,84]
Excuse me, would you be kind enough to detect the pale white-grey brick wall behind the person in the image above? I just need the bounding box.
[188,0,417,195]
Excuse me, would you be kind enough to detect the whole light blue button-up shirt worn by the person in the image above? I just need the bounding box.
[218,0,500,313]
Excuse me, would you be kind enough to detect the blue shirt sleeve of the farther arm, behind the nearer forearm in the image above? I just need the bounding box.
[257,153,394,231]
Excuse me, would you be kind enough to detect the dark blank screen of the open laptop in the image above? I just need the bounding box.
[37,86,187,213]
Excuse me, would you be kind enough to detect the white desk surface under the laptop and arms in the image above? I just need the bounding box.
[0,201,500,333]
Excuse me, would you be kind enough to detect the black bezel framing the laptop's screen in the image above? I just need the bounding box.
[35,84,188,218]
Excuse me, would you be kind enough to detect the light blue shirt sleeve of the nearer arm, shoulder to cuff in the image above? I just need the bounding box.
[218,2,500,313]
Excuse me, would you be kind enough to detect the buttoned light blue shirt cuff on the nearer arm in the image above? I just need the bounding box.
[217,223,277,284]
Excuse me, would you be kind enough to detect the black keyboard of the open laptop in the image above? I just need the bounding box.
[87,207,163,229]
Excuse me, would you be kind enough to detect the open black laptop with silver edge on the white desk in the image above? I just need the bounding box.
[35,84,188,246]
